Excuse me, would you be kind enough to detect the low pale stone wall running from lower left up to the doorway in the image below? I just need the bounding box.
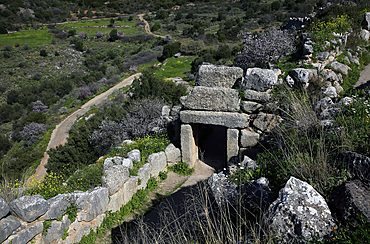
[0,144,181,244]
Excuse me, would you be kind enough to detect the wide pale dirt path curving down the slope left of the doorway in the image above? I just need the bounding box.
[28,73,141,182]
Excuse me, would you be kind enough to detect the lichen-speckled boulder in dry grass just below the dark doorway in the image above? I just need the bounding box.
[208,172,237,207]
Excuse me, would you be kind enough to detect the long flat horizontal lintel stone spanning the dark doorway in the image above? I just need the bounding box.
[180,110,249,129]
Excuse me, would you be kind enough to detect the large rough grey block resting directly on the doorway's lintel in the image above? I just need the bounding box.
[180,86,240,112]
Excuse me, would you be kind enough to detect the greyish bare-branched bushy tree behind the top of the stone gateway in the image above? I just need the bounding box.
[235,27,295,68]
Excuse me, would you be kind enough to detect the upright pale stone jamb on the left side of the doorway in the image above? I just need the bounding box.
[181,124,198,168]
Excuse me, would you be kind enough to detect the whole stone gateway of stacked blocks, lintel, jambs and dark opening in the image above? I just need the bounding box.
[180,65,281,170]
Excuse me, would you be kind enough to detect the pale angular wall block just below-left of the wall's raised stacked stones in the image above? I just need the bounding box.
[77,187,109,221]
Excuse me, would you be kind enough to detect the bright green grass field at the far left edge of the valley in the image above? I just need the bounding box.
[0,30,53,48]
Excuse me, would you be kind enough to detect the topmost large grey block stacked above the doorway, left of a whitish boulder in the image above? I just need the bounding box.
[195,65,243,88]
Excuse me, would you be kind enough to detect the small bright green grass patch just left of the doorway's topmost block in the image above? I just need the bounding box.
[155,56,194,78]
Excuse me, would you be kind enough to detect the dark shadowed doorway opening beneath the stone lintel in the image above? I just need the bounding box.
[195,124,227,172]
